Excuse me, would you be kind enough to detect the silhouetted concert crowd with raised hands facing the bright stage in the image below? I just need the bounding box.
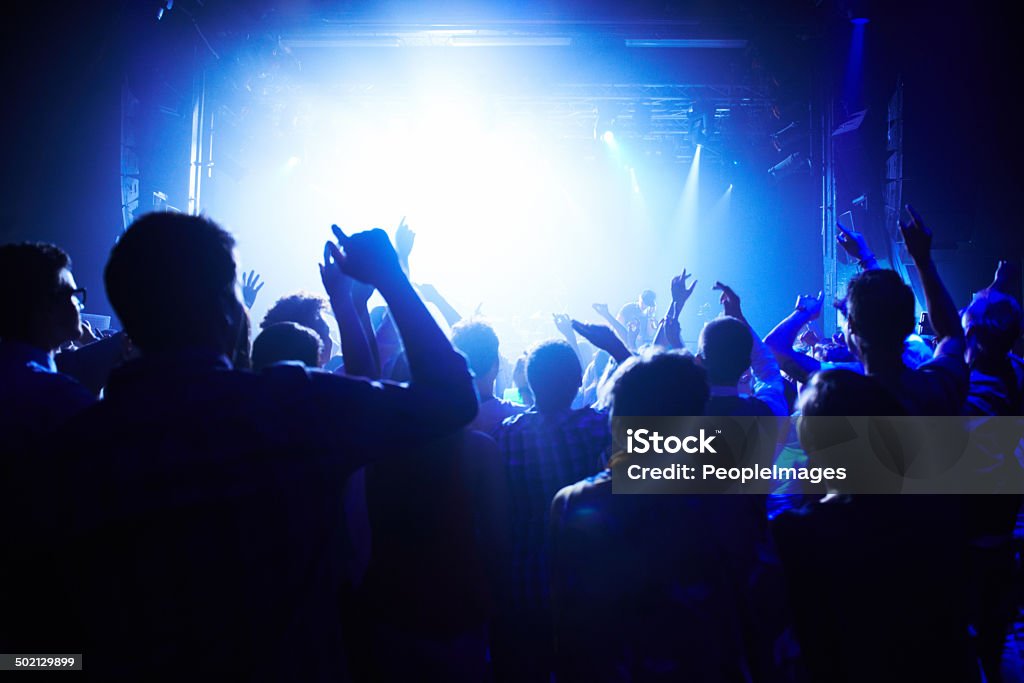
[0,207,1024,683]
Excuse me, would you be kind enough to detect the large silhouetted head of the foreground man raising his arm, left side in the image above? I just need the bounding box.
[103,213,243,357]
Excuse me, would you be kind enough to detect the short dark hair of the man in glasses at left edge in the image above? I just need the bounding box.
[0,242,71,339]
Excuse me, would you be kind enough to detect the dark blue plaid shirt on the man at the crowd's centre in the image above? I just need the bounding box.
[494,408,611,609]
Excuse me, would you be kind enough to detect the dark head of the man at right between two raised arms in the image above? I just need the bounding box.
[845,269,914,359]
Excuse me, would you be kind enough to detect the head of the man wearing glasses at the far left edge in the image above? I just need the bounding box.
[0,243,82,351]
